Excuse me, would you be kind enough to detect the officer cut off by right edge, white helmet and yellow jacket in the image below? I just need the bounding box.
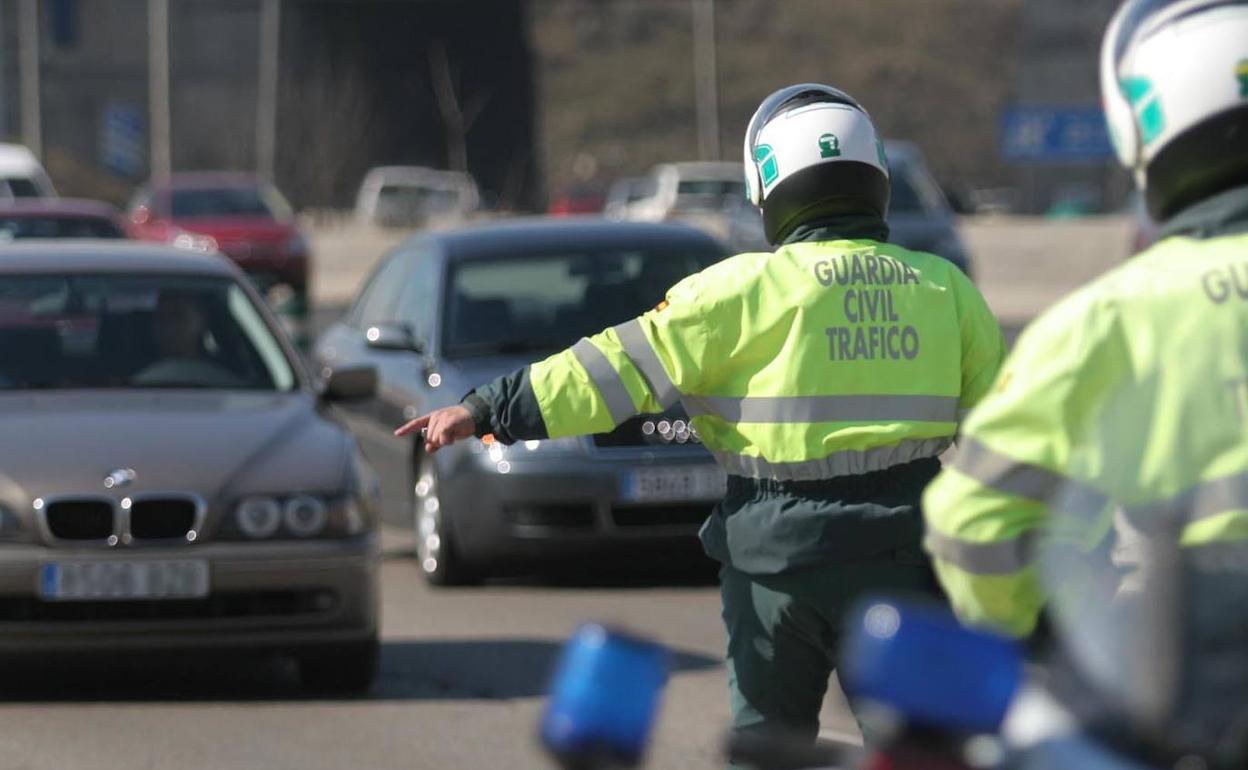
[924,0,1248,635]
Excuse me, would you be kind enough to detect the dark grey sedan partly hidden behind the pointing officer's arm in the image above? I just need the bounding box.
[314,220,725,584]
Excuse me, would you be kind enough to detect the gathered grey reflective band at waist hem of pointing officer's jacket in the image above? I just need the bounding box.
[711,438,953,482]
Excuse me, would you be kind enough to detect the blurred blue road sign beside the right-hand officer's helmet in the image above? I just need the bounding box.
[1001,105,1113,163]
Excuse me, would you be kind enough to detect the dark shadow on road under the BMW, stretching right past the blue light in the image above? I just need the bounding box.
[0,639,719,703]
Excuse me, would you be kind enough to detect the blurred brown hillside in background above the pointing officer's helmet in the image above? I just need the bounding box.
[530,0,1023,198]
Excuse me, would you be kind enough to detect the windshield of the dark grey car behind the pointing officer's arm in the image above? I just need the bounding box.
[443,247,723,358]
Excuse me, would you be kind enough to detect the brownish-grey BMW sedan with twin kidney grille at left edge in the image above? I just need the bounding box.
[0,241,378,690]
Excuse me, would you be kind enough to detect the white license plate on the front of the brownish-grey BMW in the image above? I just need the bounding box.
[39,559,208,602]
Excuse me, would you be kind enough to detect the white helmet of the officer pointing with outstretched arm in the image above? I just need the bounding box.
[744,84,889,243]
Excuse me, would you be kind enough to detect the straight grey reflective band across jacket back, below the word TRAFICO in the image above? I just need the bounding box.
[684,396,957,423]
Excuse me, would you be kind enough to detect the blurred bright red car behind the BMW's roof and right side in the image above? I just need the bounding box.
[129,172,310,343]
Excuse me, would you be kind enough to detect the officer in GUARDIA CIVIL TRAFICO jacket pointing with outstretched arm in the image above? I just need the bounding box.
[397,84,1005,740]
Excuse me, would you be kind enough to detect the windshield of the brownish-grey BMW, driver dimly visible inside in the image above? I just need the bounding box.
[0,273,296,391]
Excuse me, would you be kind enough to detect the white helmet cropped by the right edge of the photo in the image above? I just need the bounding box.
[1101,0,1248,220]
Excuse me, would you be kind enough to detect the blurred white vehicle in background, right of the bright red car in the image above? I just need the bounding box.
[356,166,480,227]
